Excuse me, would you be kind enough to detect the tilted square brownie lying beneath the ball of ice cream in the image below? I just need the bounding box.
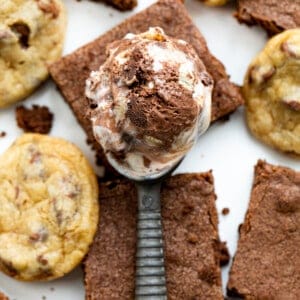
[50,0,243,176]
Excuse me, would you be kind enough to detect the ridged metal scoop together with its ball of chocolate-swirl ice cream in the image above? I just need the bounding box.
[86,28,213,299]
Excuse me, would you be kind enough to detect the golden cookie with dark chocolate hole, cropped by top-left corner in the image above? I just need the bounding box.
[0,0,66,107]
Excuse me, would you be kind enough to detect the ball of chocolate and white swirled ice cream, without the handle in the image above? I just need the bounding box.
[86,28,213,177]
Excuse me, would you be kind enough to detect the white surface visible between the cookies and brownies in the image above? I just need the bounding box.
[0,0,300,300]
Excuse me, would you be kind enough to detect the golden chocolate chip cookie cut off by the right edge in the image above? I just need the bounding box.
[243,28,300,155]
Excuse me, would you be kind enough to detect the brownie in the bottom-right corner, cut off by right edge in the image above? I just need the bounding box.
[228,161,300,300]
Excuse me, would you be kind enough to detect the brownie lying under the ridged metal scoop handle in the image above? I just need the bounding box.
[84,172,230,300]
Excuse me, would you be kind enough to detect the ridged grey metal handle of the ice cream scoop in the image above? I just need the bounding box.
[135,182,167,300]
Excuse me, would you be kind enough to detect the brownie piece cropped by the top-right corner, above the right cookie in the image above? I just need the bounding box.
[235,0,300,35]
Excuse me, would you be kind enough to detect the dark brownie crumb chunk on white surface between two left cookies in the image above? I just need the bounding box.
[16,105,53,134]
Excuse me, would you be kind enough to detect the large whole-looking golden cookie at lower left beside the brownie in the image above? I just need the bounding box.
[0,134,99,281]
